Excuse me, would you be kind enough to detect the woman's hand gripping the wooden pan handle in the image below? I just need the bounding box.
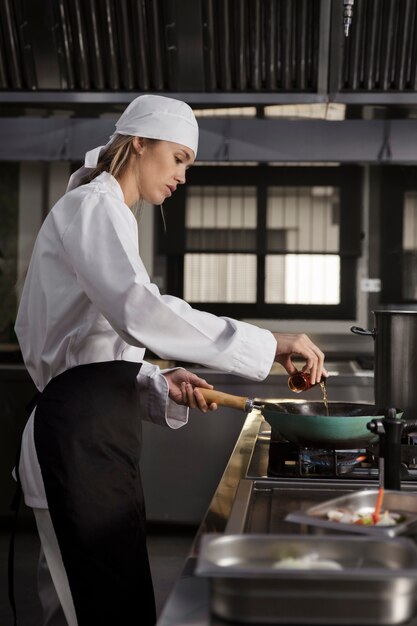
[164,369,217,413]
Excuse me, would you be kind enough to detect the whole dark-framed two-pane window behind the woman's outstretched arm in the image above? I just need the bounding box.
[159,166,360,319]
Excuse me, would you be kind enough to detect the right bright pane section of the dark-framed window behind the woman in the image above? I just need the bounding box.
[265,185,340,305]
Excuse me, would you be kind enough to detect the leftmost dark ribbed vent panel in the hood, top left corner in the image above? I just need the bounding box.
[0,0,169,91]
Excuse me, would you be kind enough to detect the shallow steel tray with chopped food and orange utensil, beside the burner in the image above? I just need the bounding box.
[285,489,417,537]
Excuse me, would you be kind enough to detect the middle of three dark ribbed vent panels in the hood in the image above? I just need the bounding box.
[202,0,320,91]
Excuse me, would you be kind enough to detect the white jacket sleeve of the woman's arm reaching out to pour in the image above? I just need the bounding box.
[62,189,276,380]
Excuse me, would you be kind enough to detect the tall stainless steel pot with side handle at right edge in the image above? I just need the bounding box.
[351,311,417,419]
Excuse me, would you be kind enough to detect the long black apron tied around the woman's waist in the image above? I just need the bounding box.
[34,361,156,626]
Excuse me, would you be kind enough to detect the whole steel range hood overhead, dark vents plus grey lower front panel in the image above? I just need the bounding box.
[0,0,417,163]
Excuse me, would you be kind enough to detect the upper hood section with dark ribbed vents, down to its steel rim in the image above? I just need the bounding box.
[0,0,417,105]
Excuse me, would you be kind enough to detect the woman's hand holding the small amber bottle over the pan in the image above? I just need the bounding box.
[273,333,328,383]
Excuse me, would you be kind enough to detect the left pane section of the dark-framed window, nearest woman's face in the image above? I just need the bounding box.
[184,185,257,304]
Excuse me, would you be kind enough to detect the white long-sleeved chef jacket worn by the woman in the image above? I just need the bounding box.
[15,172,276,508]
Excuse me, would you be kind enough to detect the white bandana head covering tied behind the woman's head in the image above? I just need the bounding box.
[67,95,198,191]
